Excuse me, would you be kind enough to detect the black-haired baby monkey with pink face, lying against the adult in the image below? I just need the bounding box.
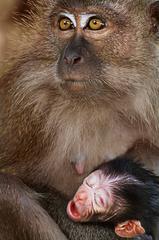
[67,157,159,240]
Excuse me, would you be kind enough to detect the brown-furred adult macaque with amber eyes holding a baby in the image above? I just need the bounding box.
[0,0,159,240]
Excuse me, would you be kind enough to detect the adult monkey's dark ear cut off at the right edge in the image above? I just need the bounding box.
[149,1,159,35]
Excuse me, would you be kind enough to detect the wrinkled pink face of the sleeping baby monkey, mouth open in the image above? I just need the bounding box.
[67,170,114,222]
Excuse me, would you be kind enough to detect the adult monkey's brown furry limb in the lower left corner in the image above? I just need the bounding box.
[0,174,66,240]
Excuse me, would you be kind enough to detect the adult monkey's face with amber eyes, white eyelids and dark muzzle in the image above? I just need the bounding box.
[46,1,156,99]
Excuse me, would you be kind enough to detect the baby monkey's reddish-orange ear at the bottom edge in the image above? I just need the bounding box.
[115,220,145,238]
